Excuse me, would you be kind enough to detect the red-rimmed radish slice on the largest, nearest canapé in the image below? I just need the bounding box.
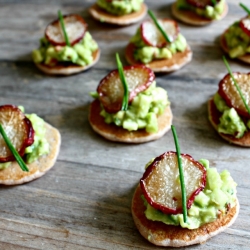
[140,152,206,214]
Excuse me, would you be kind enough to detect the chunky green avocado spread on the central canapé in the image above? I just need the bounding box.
[93,81,170,133]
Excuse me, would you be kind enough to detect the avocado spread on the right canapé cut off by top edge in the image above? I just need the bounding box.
[176,0,225,20]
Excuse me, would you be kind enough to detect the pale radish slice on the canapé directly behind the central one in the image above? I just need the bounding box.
[140,19,179,48]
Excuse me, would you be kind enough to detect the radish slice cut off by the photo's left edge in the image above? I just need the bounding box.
[0,105,35,162]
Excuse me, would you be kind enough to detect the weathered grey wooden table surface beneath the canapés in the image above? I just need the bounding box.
[0,0,250,249]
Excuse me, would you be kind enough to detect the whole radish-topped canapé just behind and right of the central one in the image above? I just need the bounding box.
[125,12,192,72]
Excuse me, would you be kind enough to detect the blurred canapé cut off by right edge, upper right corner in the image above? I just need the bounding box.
[220,5,250,63]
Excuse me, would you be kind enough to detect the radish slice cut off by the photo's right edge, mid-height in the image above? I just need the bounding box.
[218,72,250,118]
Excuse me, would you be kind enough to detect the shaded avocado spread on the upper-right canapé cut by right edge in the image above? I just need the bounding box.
[224,21,250,58]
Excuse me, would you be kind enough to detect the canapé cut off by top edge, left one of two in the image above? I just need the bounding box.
[89,0,147,25]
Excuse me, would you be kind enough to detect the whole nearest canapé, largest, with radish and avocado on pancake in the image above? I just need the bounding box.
[132,152,239,247]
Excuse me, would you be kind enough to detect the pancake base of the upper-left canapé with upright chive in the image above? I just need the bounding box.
[36,49,101,75]
